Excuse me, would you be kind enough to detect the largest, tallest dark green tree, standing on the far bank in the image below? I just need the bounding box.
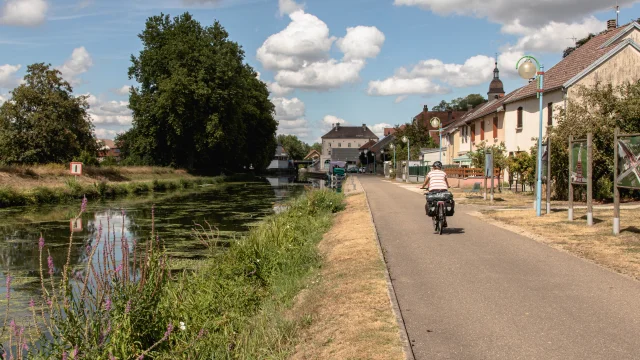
[124,13,277,170]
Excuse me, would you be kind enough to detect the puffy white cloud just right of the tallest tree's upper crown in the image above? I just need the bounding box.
[257,11,335,70]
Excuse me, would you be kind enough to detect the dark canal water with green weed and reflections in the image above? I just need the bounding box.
[0,176,305,316]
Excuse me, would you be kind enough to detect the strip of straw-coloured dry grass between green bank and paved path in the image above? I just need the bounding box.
[292,194,404,359]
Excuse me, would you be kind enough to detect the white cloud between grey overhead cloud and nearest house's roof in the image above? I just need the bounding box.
[502,16,606,52]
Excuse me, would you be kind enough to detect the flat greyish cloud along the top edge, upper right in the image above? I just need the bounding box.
[394,0,637,30]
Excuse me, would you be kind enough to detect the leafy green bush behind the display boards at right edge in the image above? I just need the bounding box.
[550,82,640,199]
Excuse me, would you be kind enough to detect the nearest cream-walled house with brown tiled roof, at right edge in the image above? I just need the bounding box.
[503,20,640,154]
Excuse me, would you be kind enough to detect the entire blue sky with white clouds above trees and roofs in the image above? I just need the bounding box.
[0,0,640,143]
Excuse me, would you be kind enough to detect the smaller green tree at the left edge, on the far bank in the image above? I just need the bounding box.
[0,63,97,164]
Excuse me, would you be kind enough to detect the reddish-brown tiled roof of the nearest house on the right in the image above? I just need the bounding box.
[504,26,627,104]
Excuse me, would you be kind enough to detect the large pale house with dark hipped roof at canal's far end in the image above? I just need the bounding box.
[320,124,378,169]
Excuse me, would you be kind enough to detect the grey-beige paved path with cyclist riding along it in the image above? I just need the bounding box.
[359,176,640,360]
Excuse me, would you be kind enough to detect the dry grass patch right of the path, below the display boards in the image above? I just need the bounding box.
[482,209,640,280]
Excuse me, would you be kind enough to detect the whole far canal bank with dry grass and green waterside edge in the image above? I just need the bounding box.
[0,164,225,208]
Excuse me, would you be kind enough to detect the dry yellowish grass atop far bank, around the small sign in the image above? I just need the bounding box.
[0,164,194,190]
